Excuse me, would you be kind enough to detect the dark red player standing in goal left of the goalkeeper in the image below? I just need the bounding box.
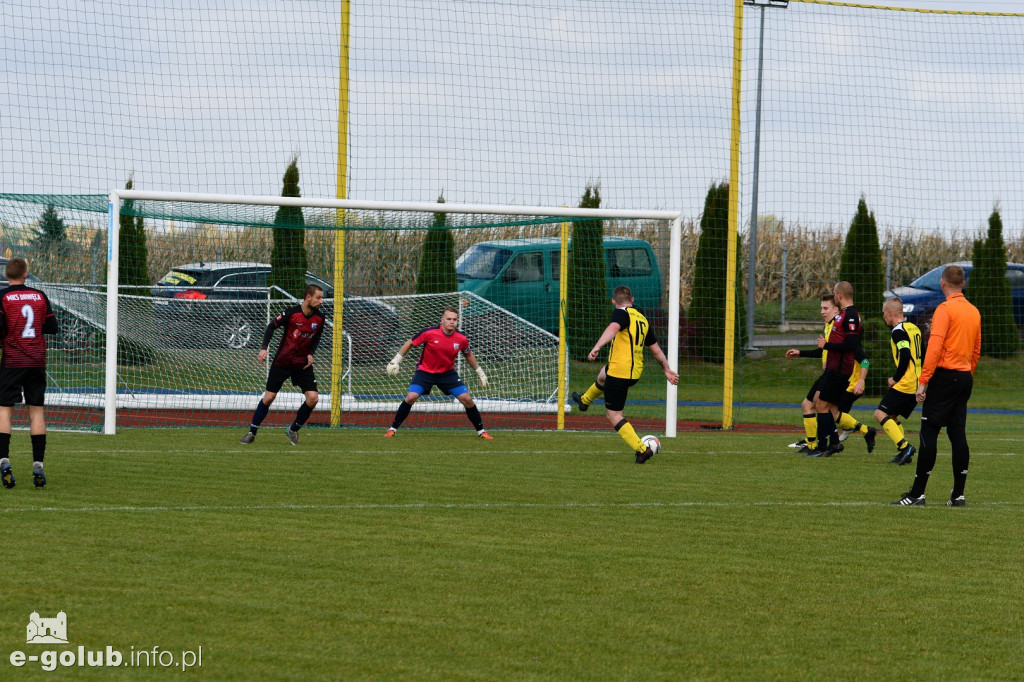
[242,285,327,445]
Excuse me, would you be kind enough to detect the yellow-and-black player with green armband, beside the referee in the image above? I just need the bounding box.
[874,296,922,466]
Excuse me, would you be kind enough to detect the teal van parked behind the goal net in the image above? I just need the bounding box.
[456,237,662,334]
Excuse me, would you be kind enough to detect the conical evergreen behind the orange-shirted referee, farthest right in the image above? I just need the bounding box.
[964,209,1020,357]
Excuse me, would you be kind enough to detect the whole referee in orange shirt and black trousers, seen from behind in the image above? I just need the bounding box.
[893,265,981,507]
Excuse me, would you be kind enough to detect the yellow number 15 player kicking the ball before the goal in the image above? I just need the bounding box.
[572,286,679,464]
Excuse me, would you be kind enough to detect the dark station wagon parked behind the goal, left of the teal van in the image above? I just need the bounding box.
[152,262,398,361]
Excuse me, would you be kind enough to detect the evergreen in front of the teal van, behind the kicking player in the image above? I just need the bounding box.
[565,183,611,360]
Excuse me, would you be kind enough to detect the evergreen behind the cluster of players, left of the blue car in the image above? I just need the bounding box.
[839,197,892,395]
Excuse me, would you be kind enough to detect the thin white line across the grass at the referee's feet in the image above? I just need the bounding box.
[0,501,1024,513]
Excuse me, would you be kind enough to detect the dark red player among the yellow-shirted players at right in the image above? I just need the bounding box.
[812,282,862,457]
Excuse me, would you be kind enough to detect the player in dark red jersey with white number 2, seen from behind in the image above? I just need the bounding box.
[0,258,57,487]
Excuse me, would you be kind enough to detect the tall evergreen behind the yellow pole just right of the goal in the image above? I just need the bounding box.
[687,182,746,363]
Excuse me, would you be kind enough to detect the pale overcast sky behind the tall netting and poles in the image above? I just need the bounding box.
[0,0,1024,231]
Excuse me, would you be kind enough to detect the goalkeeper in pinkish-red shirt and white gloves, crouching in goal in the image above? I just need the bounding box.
[384,307,494,440]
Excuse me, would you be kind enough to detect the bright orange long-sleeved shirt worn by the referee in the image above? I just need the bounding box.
[918,293,981,384]
